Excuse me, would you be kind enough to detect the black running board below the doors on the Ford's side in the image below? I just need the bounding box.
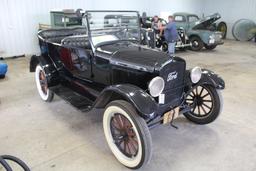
[51,85,93,112]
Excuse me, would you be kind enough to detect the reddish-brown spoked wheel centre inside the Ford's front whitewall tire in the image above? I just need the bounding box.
[110,114,139,158]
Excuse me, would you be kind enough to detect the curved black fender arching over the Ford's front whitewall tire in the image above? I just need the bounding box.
[94,84,158,119]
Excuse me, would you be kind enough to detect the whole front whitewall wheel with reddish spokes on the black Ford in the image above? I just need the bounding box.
[103,100,152,169]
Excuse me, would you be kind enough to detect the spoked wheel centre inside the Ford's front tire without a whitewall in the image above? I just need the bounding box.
[186,86,213,117]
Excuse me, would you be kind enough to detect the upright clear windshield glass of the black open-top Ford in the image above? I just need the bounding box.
[87,11,140,46]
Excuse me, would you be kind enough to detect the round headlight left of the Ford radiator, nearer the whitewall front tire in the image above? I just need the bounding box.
[148,77,165,97]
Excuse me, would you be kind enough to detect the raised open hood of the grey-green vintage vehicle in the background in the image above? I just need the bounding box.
[192,13,221,29]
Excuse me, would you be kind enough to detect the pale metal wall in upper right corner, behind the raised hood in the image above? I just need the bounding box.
[202,0,256,39]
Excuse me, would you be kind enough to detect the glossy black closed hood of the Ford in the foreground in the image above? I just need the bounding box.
[97,42,170,72]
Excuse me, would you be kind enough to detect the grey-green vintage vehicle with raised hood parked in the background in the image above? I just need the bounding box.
[173,12,224,51]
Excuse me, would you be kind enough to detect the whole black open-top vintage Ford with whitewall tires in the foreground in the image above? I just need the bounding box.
[30,11,225,169]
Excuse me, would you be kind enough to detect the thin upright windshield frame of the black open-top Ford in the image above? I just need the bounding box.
[83,10,141,51]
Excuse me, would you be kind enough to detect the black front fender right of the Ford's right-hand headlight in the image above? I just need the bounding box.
[197,69,225,90]
